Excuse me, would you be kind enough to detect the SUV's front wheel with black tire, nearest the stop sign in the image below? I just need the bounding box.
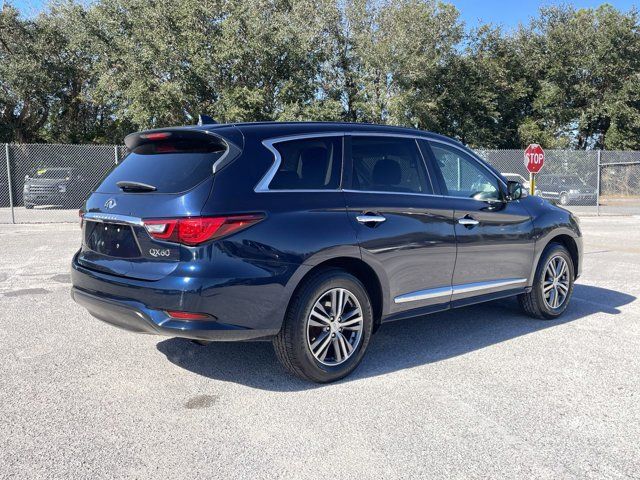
[518,243,575,320]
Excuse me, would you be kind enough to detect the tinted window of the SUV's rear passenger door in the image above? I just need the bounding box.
[351,136,433,193]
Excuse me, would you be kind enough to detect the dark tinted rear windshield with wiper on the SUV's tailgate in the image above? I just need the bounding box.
[96,141,226,193]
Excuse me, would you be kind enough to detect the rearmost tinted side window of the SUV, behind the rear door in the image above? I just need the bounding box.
[269,137,342,190]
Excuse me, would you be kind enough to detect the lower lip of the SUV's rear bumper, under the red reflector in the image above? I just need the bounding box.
[71,287,278,341]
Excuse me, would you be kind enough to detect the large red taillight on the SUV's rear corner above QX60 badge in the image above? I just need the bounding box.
[144,215,264,245]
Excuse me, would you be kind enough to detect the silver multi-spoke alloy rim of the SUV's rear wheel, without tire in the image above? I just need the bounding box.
[307,288,364,366]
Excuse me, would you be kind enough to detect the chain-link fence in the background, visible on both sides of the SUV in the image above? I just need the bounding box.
[0,144,640,223]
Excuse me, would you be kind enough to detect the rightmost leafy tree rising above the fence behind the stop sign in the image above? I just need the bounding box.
[518,4,640,149]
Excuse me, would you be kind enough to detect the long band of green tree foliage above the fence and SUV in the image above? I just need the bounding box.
[0,0,640,149]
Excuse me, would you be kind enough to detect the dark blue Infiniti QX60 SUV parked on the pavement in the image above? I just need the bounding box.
[72,123,582,382]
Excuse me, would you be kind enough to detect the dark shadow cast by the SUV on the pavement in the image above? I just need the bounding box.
[157,284,636,391]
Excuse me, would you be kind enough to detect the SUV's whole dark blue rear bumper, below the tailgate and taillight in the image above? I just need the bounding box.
[71,254,297,341]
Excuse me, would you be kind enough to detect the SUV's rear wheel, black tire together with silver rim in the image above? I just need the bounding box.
[273,269,373,383]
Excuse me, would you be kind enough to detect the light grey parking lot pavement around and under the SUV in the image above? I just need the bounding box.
[0,217,640,479]
